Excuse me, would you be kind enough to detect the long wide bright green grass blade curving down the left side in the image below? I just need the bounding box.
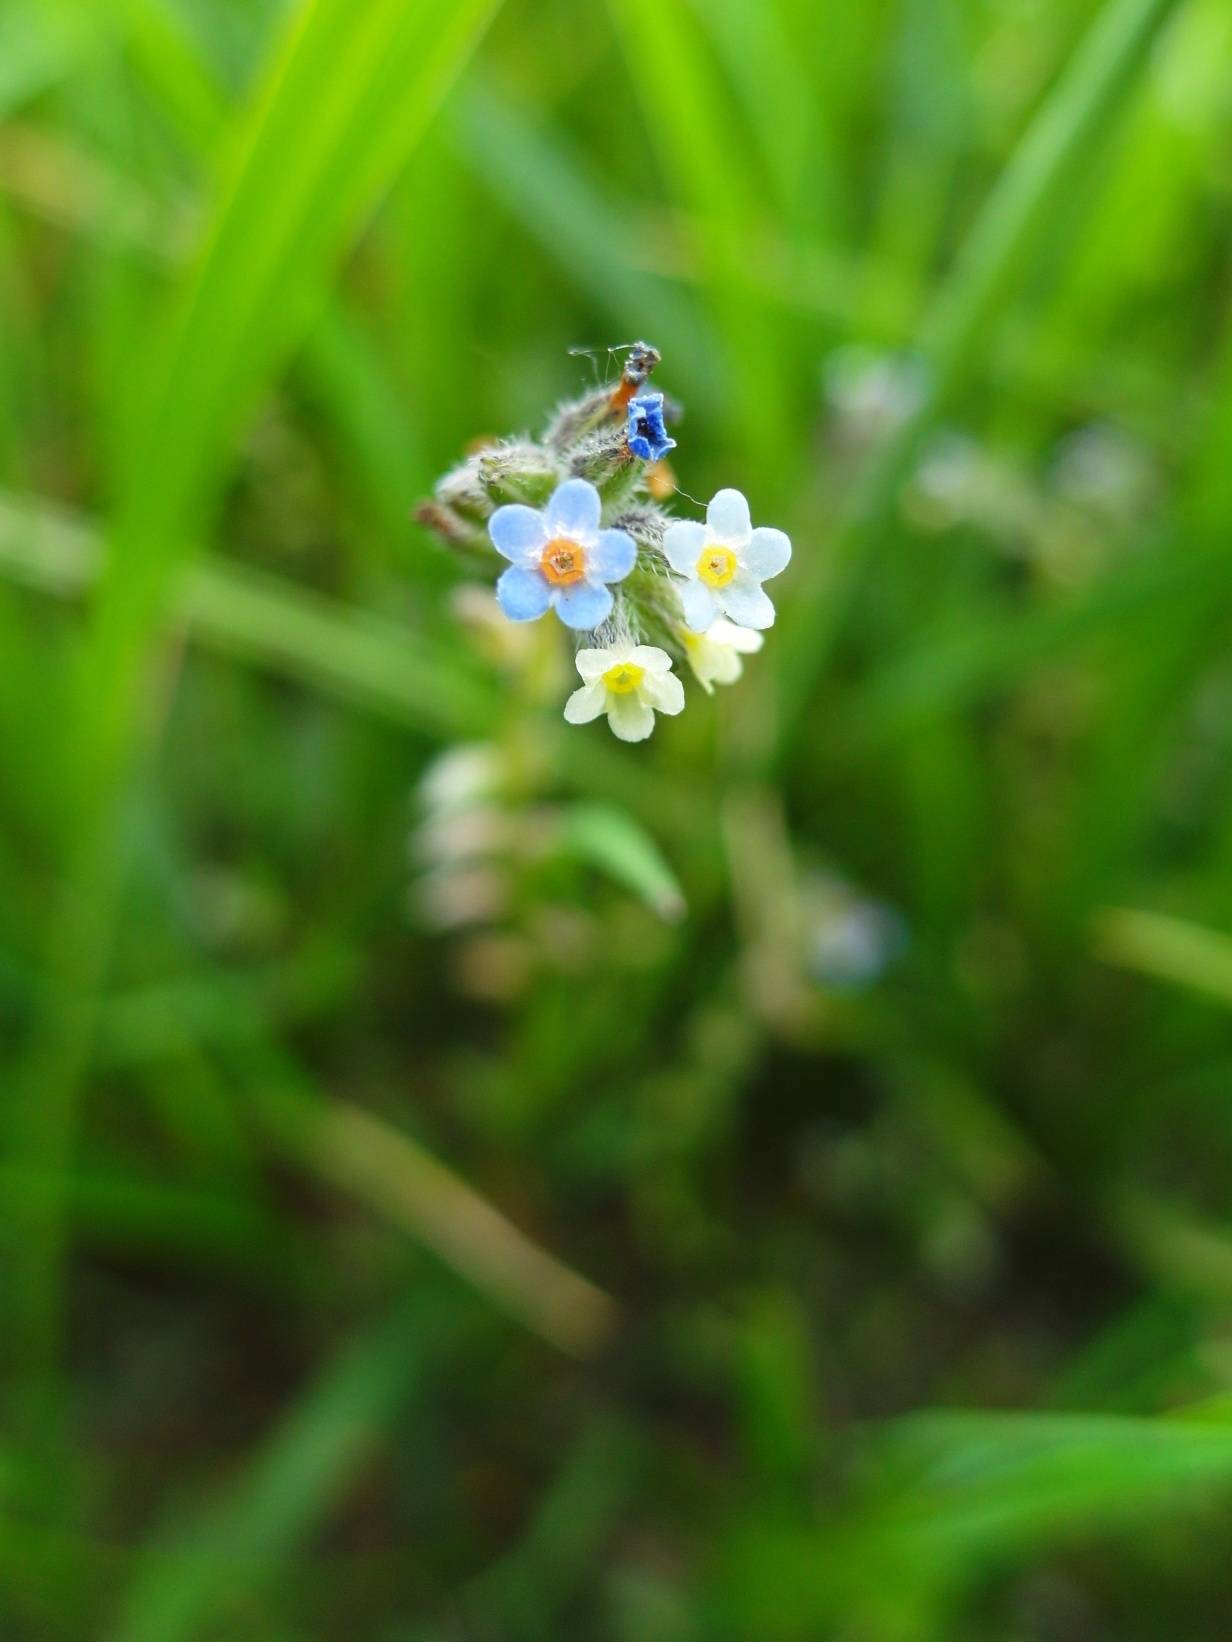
[15,0,494,1464]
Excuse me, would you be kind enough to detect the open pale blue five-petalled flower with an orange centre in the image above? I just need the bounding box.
[488,479,637,632]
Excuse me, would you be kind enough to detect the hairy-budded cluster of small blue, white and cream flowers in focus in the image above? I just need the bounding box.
[417,343,792,741]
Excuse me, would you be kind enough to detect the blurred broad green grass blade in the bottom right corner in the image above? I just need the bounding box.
[713,1407,1232,1642]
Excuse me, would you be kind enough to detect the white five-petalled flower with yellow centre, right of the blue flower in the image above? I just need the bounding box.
[664,491,792,632]
